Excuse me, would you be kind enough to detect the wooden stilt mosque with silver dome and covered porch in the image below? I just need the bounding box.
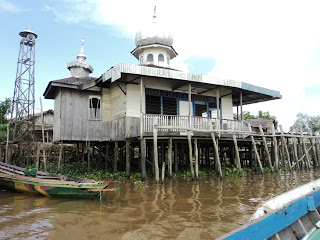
[43,6,281,180]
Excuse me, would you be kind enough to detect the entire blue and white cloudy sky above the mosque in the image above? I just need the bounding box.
[0,0,320,130]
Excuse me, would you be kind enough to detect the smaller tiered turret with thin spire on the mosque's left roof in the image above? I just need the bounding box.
[67,38,93,78]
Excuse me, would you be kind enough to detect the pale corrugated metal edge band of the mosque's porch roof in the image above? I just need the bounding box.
[103,63,281,101]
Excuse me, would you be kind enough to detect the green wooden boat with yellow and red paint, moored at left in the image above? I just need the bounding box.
[0,162,115,199]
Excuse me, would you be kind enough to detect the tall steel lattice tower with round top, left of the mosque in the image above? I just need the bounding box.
[11,30,38,139]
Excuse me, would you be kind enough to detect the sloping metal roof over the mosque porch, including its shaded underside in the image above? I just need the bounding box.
[102,64,281,105]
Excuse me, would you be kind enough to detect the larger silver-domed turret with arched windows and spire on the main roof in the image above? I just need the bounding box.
[131,6,178,67]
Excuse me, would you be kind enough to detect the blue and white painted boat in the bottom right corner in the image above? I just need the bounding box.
[219,179,320,240]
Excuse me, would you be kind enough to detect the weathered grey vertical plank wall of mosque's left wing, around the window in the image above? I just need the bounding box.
[54,89,140,141]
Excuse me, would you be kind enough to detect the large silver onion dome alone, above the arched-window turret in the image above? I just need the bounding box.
[136,22,173,47]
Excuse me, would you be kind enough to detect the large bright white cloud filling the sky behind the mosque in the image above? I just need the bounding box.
[45,0,320,127]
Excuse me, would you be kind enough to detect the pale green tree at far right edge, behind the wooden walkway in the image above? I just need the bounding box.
[291,113,320,133]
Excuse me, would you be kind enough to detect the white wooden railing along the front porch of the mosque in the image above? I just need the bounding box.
[143,114,250,132]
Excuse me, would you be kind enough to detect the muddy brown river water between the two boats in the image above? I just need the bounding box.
[0,172,320,240]
